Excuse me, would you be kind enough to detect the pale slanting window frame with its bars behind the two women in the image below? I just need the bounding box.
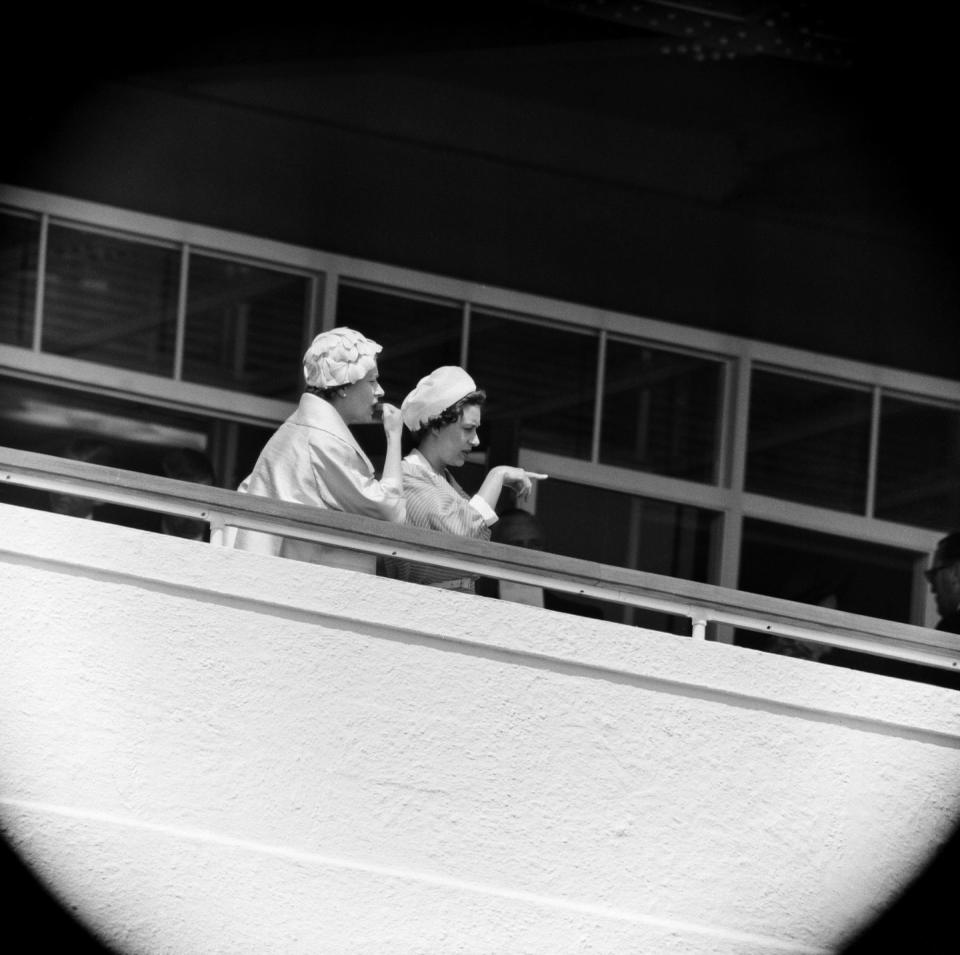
[0,184,960,626]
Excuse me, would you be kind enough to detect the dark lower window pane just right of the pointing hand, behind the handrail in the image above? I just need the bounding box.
[537,477,717,634]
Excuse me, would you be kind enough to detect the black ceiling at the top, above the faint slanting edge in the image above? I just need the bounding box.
[4,0,952,246]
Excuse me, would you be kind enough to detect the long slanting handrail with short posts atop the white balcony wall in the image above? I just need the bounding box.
[0,447,960,670]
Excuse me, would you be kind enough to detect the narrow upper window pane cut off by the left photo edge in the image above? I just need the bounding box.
[0,213,40,348]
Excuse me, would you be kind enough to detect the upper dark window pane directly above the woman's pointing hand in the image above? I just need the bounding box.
[467,312,598,460]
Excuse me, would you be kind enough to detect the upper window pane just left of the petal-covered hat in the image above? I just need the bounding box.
[183,253,310,398]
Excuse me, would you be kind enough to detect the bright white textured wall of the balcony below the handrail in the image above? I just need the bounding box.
[0,507,960,955]
